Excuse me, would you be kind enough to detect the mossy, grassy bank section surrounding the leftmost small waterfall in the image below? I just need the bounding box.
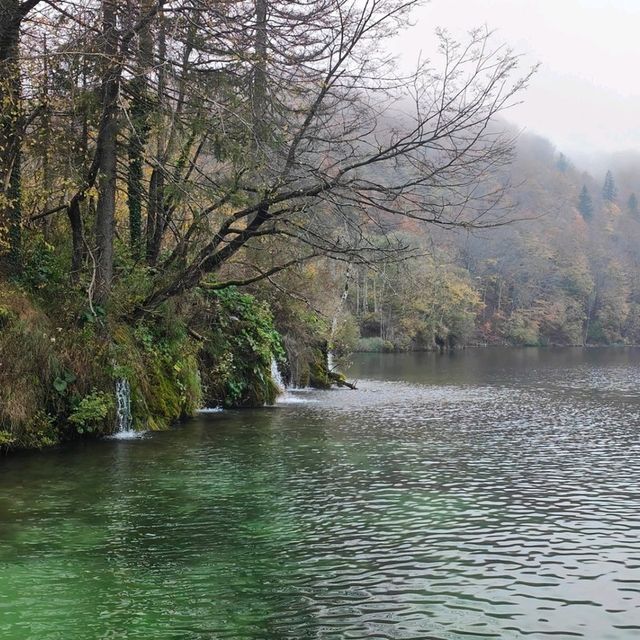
[0,282,201,449]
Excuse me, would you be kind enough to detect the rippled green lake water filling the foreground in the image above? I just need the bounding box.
[0,349,640,640]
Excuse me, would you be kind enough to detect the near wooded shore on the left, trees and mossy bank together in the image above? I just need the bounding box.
[0,0,531,447]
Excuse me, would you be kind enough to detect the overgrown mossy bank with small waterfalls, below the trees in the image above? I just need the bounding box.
[0,282,331,451]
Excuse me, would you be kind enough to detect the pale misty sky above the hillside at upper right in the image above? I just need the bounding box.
[396,0,640,154]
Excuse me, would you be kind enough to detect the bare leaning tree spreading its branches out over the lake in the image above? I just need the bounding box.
[132,13,529,312]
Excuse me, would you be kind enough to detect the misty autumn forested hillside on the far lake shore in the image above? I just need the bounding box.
[349,134,640,349]
